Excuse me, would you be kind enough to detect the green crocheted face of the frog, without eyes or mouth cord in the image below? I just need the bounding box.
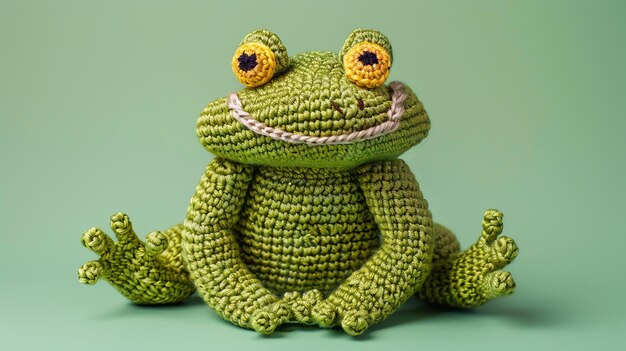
[196,52,430,169]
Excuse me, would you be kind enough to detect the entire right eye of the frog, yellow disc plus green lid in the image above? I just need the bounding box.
[340,29,393,88]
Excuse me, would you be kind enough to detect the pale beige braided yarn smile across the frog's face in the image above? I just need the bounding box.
[228,82,407,146]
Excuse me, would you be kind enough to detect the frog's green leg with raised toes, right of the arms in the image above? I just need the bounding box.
[418,210,519,308]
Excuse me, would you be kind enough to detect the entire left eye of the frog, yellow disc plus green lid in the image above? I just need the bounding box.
[232,29,289,88]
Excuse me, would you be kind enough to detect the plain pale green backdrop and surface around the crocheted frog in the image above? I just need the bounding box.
[0,0,626,350]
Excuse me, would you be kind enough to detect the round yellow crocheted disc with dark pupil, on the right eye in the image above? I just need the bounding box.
[343,41,391,88]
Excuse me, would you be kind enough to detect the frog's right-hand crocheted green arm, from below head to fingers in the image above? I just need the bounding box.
[313,159,434,335]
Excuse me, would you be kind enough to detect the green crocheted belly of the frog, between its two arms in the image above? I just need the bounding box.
[236,167,380,294]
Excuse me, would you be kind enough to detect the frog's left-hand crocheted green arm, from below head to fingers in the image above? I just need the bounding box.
[182,157,278,333]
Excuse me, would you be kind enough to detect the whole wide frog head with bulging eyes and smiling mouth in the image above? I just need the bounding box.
[196,29,430,169]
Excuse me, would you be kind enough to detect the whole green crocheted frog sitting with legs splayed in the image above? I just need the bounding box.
[79,29,518,335]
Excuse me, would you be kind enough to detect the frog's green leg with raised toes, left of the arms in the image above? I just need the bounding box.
[78,213,194,304]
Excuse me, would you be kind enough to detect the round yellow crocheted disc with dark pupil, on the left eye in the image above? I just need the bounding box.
[232,42,276,88]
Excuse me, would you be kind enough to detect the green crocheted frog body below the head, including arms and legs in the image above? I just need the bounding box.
[80,158,517,335]
